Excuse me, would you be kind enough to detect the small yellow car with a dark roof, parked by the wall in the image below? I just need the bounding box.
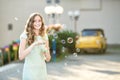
[75,29,107,53]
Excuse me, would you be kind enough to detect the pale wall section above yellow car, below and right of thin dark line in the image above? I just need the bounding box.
[79,0,120,44]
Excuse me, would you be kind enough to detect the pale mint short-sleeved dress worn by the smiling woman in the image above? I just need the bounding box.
[20,33,48,80]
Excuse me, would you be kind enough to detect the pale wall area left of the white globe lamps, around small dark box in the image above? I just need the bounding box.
[0,0,46,47]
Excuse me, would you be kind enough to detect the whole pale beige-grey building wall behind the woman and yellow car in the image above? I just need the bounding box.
[0,0,120,47]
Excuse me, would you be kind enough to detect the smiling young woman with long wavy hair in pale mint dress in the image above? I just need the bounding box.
[19,13,51,80]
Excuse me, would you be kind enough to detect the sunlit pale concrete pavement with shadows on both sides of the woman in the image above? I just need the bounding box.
[0,49,120,80]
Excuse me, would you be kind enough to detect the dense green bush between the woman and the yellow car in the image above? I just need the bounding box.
[49,30,77,59]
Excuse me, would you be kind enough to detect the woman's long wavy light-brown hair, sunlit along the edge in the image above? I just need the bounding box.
[25,13,45,45]
